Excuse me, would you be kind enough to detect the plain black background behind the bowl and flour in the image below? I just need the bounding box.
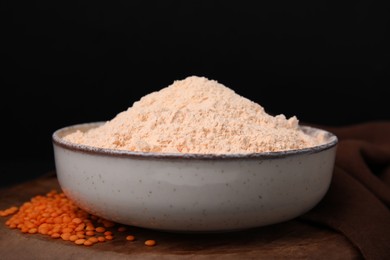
[0,0,390,185]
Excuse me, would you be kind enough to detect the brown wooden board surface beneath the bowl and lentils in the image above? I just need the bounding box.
[0,175,361,260]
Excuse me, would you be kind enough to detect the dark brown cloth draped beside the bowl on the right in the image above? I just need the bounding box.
[301,122,390,259]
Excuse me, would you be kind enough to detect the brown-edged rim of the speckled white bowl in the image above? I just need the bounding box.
[52,122,338,160]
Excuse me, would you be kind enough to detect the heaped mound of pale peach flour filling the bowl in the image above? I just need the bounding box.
[65,76,324,154]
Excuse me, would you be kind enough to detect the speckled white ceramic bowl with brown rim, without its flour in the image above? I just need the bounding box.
[53,123,337,232]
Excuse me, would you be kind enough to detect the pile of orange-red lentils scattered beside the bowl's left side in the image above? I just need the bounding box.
[0,190,156,249]
